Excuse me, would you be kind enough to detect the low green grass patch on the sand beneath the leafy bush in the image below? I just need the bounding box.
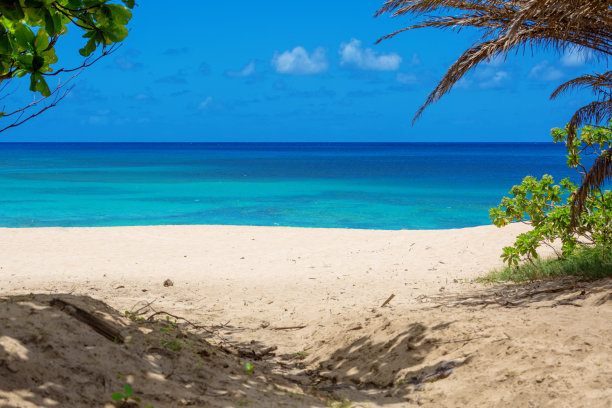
[482,247,612,283]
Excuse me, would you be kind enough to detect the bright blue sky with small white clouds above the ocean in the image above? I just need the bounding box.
[1,0,604,142]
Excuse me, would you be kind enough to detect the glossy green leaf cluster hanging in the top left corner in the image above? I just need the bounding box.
[0,0,134,96]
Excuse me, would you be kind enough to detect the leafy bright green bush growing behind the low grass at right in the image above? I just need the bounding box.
[489,120,612,267]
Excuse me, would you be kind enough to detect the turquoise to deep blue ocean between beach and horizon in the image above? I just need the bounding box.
[0,143,577,229]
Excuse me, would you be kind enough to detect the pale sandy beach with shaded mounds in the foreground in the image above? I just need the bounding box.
[0,225,612,408]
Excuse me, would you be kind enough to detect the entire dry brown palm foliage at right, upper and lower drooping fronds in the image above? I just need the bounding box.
[375,0,612,225]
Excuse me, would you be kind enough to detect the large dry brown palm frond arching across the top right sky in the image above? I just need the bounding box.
[375,0,612,122]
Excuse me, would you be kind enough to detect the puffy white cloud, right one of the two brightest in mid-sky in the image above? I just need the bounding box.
[340,38,402,71]
